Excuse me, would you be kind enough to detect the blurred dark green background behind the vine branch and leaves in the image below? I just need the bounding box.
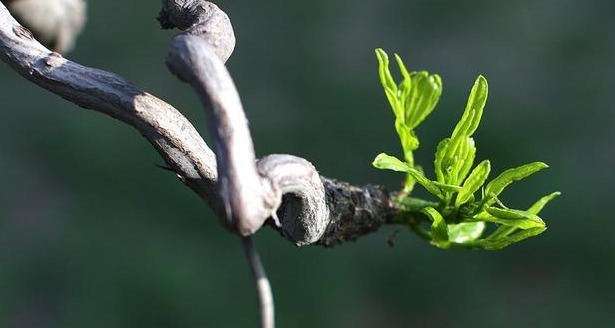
[0,0,615,328]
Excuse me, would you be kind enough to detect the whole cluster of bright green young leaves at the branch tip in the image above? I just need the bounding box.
[372,49,560,250]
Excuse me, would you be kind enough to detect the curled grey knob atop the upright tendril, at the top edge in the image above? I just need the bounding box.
[158,0,235,62]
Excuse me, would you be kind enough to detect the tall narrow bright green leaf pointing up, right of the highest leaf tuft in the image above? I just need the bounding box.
[451,75,488,139]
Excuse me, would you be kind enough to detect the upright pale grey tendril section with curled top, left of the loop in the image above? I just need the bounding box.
[161,0,279,236]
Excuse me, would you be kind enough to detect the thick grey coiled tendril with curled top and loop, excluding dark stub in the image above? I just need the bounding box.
[160,1,336,241]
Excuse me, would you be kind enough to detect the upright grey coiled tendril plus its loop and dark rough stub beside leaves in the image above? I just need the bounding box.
[160,0,396,246]
